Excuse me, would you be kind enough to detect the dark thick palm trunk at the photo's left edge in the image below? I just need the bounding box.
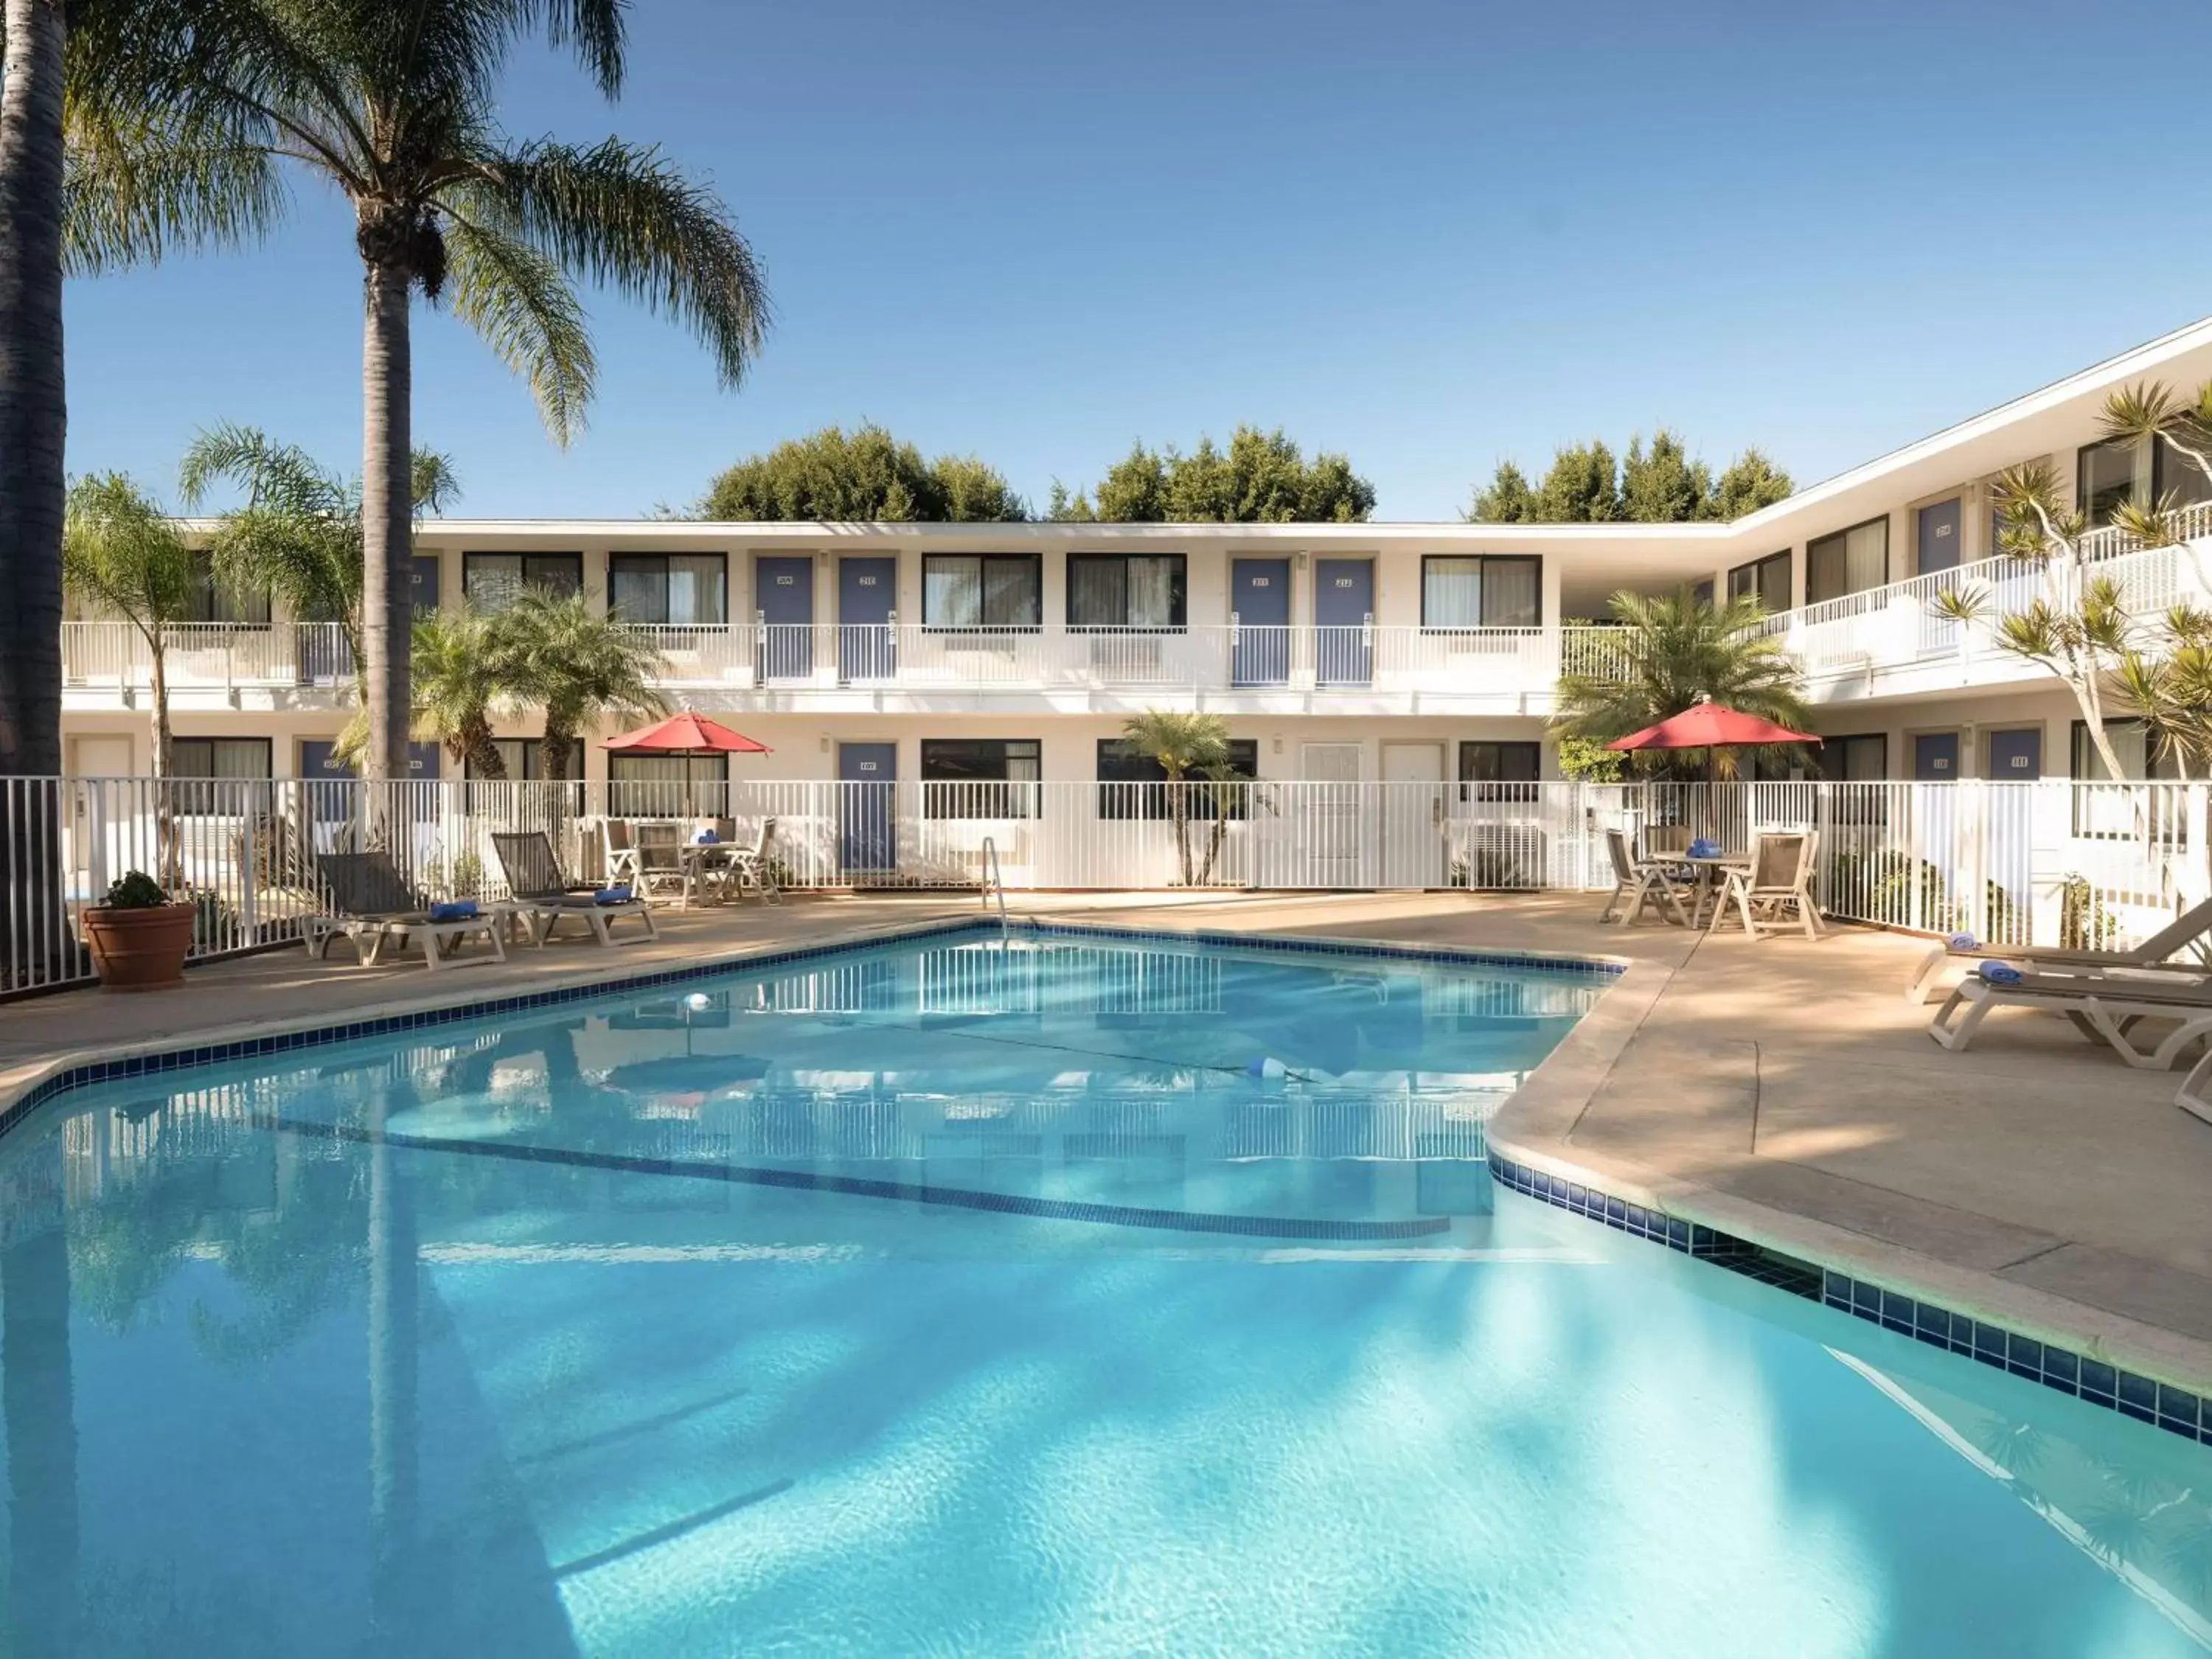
[0,0,71,984]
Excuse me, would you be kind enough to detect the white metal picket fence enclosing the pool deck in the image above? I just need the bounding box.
[0,779,2208,991]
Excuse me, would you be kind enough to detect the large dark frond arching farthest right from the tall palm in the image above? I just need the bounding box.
[451,139,768,387]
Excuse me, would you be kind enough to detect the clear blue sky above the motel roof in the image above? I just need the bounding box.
[56,0,2212,520]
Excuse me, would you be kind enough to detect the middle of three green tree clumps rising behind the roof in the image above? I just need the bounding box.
[1051,427,1376,524]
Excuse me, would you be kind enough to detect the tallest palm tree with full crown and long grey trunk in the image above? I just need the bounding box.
[66,0,768,779]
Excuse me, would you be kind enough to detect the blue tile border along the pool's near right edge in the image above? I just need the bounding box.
[1491,1150,2212,1447]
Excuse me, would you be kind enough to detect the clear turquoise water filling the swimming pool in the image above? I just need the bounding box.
[0,936,2212,1659]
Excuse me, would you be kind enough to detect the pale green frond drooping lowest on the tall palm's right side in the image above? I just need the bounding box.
[445,215,597,447]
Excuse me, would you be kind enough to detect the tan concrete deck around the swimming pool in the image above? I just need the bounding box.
[0,894,2212,1389]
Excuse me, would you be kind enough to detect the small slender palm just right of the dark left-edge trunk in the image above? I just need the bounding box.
[62,473,199,889]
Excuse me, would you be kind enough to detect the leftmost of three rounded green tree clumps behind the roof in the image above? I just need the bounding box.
[699,422,1029,524]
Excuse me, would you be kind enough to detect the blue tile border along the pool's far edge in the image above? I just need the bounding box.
[0,918,1624,1135]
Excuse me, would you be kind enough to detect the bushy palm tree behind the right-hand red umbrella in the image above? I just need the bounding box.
[1551,588,1807,776]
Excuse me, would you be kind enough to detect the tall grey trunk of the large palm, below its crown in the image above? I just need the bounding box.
[361,261,414,796]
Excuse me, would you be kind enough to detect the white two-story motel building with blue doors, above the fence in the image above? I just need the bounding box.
[64,321,2212,814]
